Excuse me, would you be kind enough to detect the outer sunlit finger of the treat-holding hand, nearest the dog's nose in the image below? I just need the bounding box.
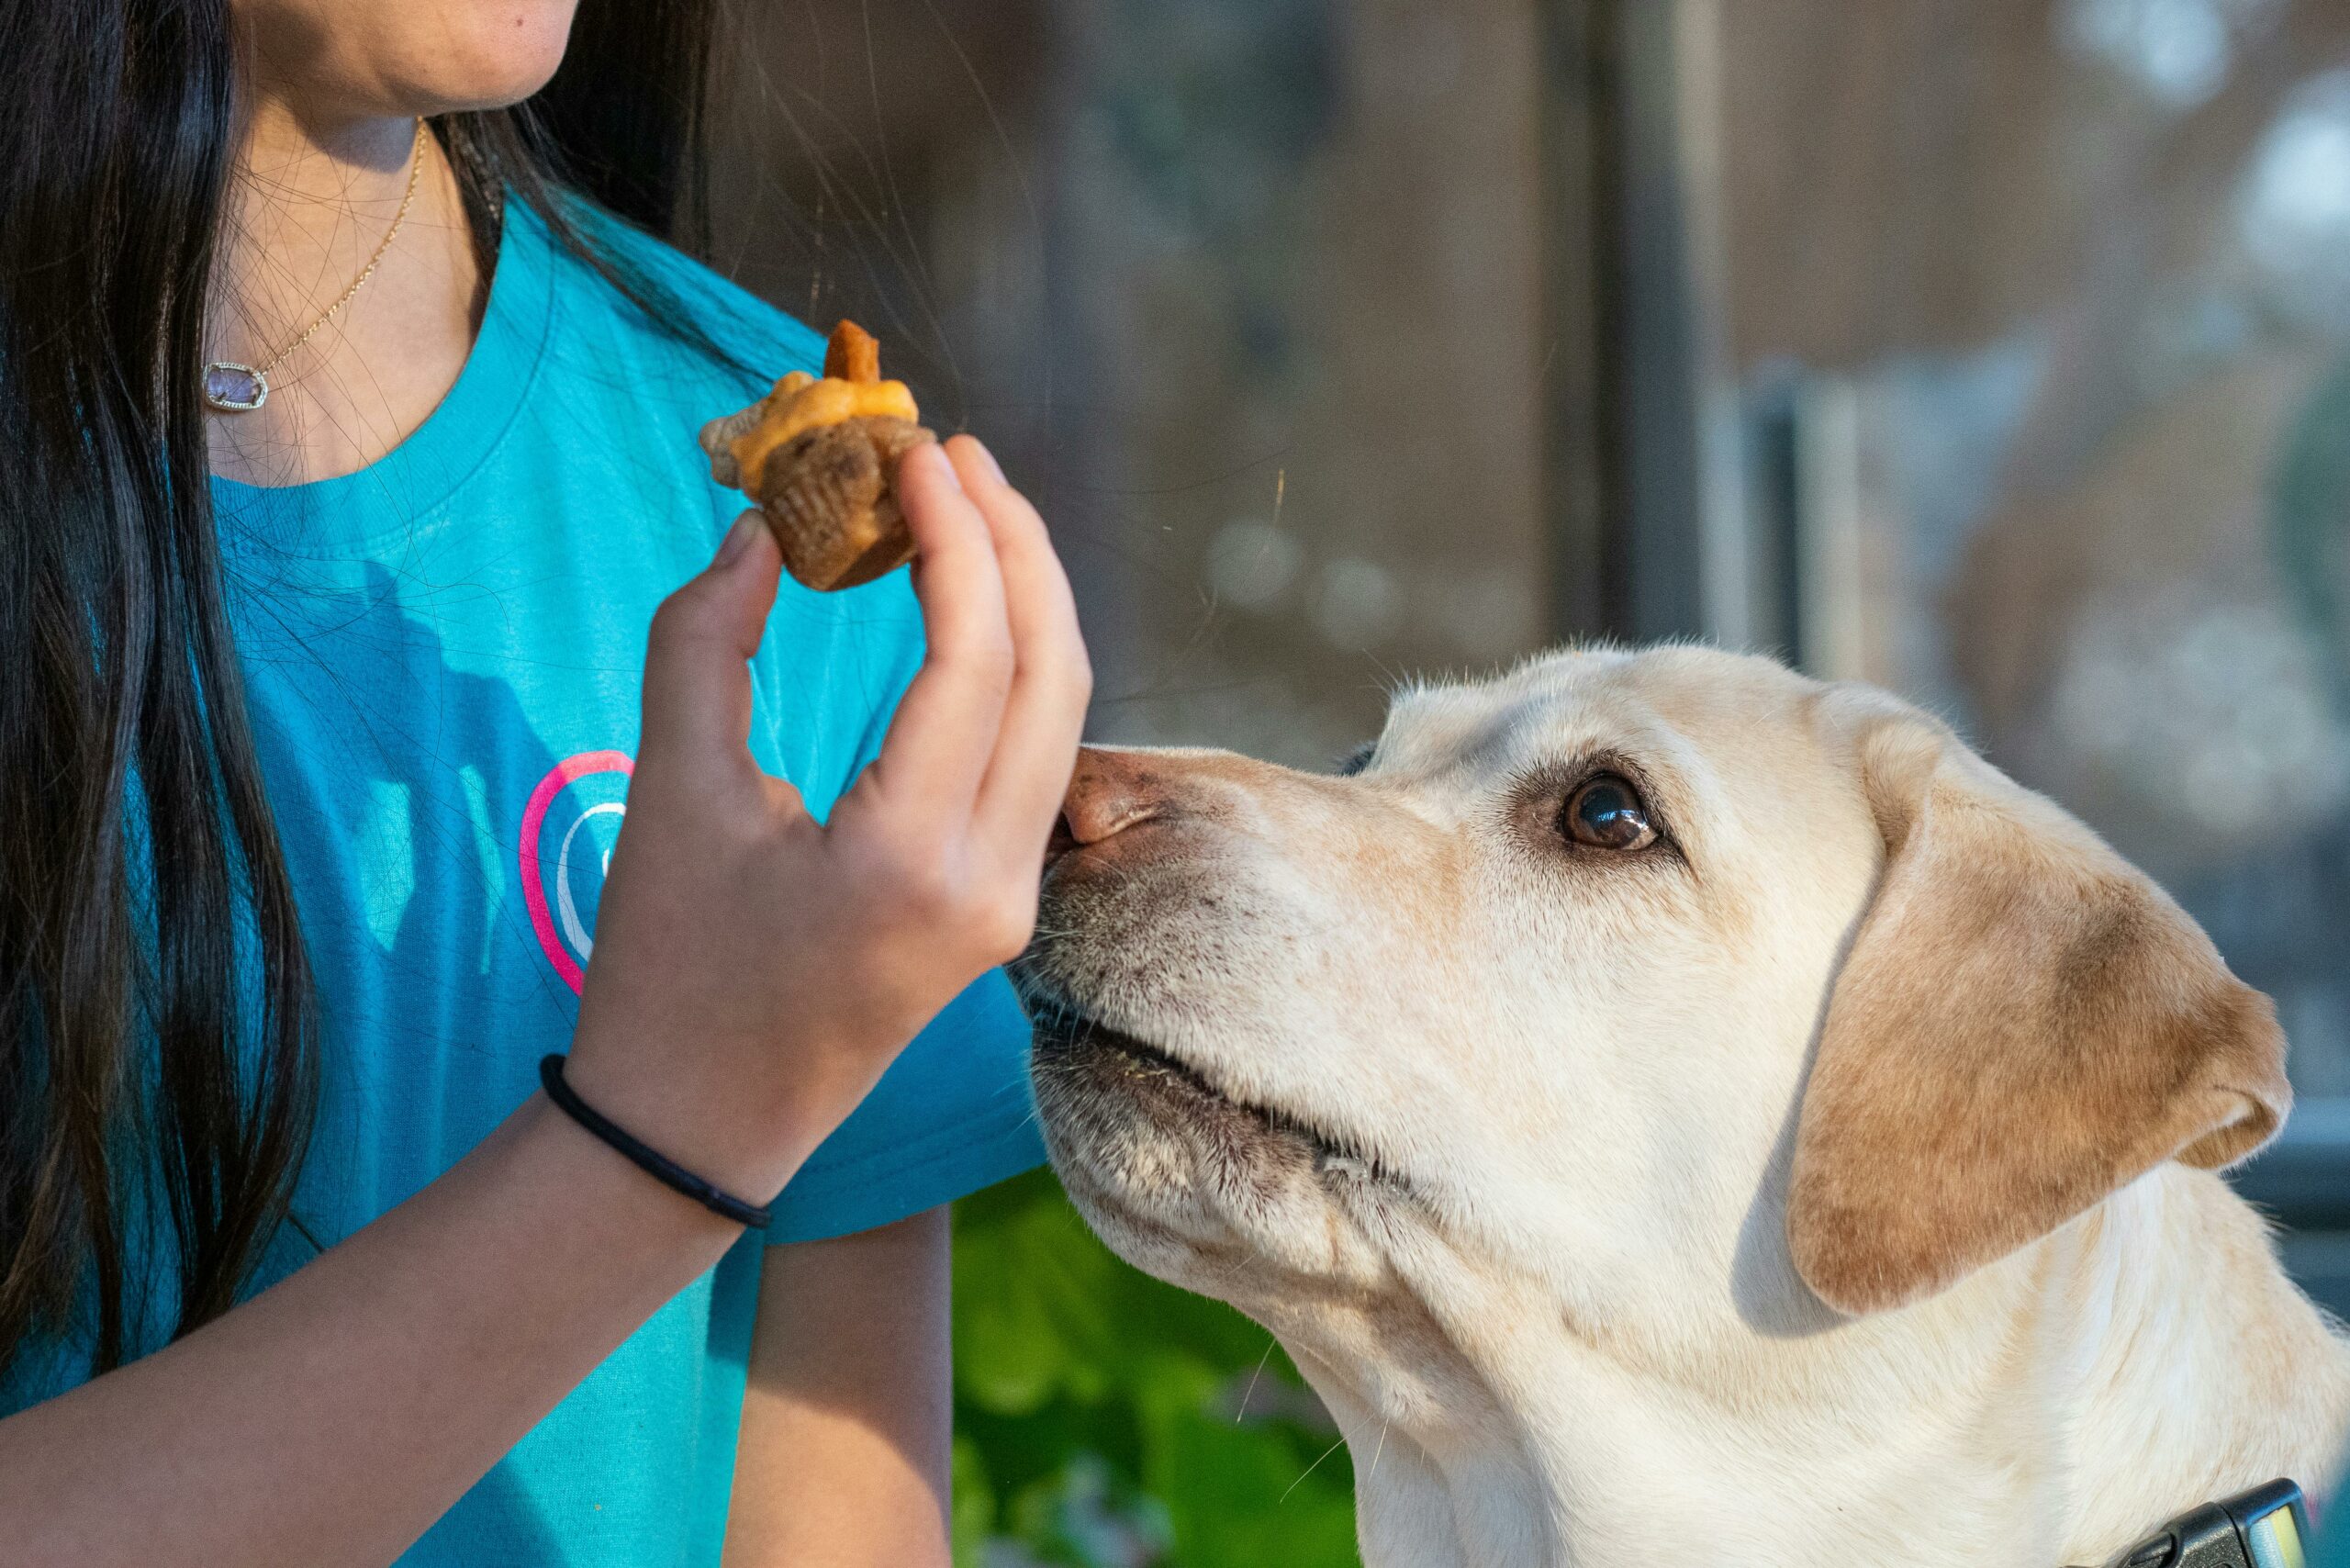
[947,435,1092,860]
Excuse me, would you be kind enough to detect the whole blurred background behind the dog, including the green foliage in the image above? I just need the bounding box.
[712,0,2350,1568]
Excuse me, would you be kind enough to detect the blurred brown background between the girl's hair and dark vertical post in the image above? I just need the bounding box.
[714,0,1556,764]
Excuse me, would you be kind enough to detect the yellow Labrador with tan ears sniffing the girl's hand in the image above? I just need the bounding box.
[1020,649,2350,1568]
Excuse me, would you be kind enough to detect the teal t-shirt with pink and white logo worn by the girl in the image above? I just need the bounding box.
[0,202,1044,1568]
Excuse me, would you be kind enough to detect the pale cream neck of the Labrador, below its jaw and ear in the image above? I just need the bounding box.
[1290,1166,2350,1568]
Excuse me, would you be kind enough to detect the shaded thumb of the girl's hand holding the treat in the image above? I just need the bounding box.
[639,512,782,773]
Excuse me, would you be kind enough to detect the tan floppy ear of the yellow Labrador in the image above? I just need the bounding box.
[1786,710,2291,1312]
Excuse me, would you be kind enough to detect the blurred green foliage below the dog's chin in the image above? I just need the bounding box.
[954,1170,1356,1568]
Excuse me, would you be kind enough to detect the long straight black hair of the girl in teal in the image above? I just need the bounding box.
[0,0,714,1371]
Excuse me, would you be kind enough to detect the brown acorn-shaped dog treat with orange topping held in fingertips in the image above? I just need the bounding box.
[702,322,937,592]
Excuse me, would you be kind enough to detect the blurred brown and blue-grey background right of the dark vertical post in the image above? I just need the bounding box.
[1701,0,2350,1104]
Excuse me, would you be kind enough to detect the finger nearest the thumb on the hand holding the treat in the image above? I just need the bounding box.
[872,444,1013,830]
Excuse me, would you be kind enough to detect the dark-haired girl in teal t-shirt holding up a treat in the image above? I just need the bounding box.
[0,0,1091,1568]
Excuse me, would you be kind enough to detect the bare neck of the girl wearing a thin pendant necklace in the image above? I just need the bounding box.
[205,92,488,485]
